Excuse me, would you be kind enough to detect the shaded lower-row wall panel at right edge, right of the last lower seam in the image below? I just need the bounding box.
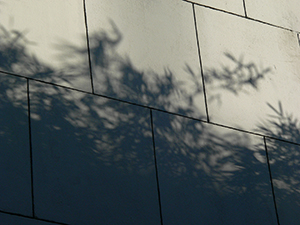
[267,139,300,225]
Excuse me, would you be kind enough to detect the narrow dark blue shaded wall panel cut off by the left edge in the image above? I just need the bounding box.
[0,74,32,216]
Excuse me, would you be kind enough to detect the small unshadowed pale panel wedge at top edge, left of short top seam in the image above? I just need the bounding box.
[192,0,245,16]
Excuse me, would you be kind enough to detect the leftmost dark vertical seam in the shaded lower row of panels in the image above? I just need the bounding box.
[26,79,35,217]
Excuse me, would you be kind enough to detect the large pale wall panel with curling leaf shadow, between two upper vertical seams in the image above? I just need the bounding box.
[87,0,205,118]
